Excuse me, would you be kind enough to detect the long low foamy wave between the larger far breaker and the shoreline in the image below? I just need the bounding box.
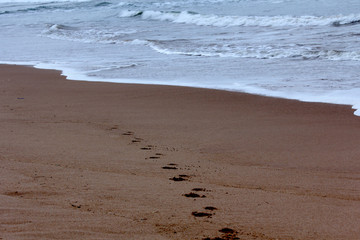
[42,24,360,61]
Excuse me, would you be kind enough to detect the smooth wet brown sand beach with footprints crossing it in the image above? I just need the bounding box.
[0,65,360,240]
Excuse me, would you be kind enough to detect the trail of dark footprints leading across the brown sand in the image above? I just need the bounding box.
[116,126,240,240]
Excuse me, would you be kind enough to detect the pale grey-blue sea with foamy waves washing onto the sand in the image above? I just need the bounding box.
[0,0,360,115]
